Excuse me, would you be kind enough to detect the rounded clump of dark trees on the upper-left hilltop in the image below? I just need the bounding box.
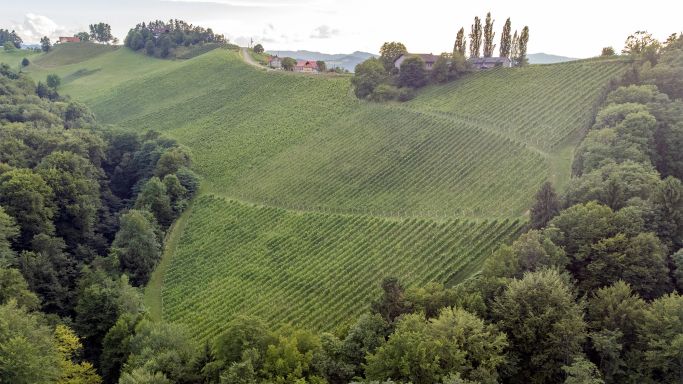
[124,19,226,58]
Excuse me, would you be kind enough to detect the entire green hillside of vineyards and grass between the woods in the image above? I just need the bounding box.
[6,45,625,339]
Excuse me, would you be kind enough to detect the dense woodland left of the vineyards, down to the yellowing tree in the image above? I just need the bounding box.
[0,64,199,383]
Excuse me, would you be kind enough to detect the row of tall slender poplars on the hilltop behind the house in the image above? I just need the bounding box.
[453,12,529,65]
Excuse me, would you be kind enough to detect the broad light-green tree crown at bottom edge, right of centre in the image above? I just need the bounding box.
[366,308,507,383]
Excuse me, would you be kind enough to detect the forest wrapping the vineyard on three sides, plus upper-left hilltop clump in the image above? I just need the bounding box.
[0,24,683,384]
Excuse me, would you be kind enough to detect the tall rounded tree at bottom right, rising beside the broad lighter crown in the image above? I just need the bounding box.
[492,270,586,383]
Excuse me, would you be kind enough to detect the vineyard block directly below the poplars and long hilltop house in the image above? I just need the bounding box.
[408,60,626,151]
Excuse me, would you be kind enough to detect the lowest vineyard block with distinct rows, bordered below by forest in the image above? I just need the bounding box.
[162,196,522,340]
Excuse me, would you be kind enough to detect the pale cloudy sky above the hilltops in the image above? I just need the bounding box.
[0,0,683,58]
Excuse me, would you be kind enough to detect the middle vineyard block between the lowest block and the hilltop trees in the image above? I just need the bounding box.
[228,106,548,218]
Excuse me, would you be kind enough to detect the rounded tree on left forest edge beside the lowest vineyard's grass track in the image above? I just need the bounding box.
[111,208,163,286]
